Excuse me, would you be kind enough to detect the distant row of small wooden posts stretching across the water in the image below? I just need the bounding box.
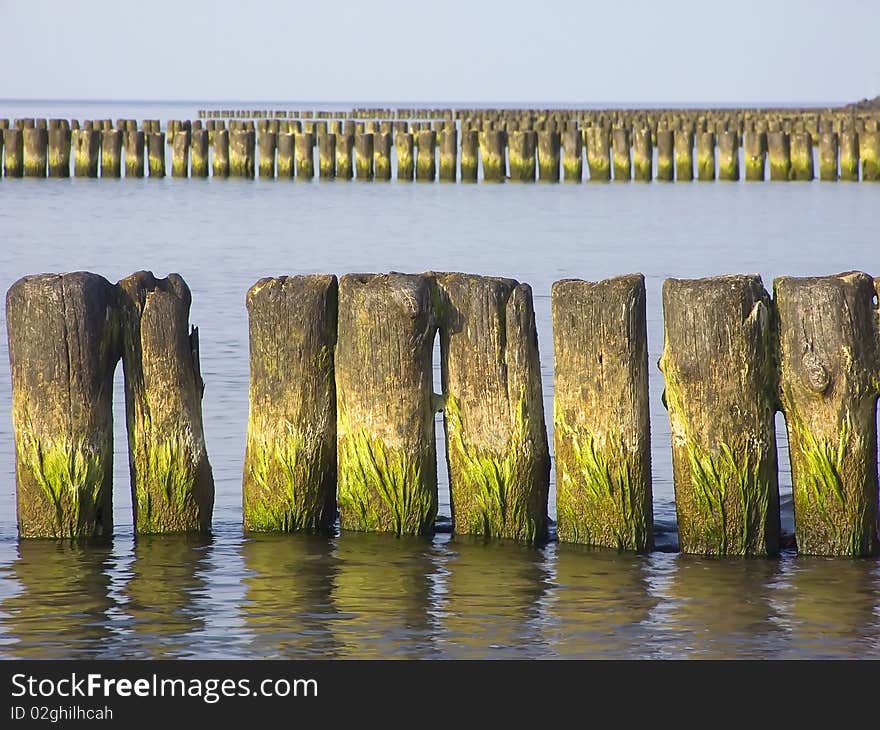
[0,111,880,182]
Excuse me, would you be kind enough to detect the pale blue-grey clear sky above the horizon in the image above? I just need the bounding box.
[0,0,880,104]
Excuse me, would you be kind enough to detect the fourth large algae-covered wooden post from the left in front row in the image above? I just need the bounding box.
[336,273,437,535]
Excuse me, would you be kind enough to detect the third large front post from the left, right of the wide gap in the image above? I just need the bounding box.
[243,272,337,532]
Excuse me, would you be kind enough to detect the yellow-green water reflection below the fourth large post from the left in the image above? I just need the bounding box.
[332,532,436,659]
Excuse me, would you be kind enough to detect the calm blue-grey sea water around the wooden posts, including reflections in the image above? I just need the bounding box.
[0,103,880,658]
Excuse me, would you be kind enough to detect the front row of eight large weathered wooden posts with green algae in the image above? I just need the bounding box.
[7,272,880,556]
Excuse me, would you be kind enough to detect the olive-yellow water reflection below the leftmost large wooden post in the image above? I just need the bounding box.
[0,540,114,659]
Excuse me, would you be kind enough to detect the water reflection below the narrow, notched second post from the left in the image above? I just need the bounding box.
[123,535,211,659]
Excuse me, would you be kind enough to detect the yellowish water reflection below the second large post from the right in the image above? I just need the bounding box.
[663,555,783,659]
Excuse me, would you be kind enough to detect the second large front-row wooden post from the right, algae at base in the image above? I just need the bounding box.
[660,276,780,555]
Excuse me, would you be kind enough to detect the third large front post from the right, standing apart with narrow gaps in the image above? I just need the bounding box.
[552,276,659,551]
